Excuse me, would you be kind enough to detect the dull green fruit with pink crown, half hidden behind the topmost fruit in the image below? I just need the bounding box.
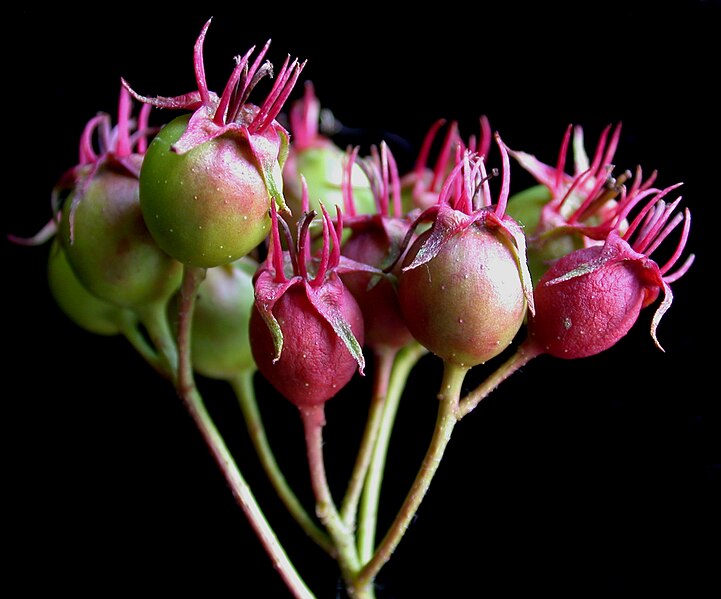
[58,89,182,309]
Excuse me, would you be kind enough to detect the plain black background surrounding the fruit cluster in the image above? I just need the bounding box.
[2,1,721,599]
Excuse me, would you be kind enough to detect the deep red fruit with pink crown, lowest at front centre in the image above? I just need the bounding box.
[250,202,372,407]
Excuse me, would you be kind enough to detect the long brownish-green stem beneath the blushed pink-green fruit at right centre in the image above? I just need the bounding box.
[356,361,468,584]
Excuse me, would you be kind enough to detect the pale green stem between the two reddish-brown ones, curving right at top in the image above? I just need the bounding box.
[358,343,428,563]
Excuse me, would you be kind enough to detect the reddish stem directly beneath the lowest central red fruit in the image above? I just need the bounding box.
[299,404,373,599]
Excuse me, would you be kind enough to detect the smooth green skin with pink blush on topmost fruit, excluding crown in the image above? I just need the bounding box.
[140,115,282,268]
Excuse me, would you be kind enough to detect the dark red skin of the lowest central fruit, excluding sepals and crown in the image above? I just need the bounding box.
[250,285,363,407]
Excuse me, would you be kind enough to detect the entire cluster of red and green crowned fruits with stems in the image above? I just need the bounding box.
[16,21,693,598]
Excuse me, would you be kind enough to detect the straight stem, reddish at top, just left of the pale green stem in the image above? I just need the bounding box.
[341,348,396,526]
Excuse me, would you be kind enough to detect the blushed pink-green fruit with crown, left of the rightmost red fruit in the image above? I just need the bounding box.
[398,144,532,368]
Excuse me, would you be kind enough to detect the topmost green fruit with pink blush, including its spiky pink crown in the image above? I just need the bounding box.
[126,21,303,268]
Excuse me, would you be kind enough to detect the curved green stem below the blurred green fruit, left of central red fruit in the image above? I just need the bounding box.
[229,368,335,555]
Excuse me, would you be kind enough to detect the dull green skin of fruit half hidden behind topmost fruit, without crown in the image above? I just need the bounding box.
[58,154,182,308]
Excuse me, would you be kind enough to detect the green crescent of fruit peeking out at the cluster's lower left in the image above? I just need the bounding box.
[47,238,123,336]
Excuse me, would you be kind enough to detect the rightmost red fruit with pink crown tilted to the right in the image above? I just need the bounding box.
[528,186,693,359]
